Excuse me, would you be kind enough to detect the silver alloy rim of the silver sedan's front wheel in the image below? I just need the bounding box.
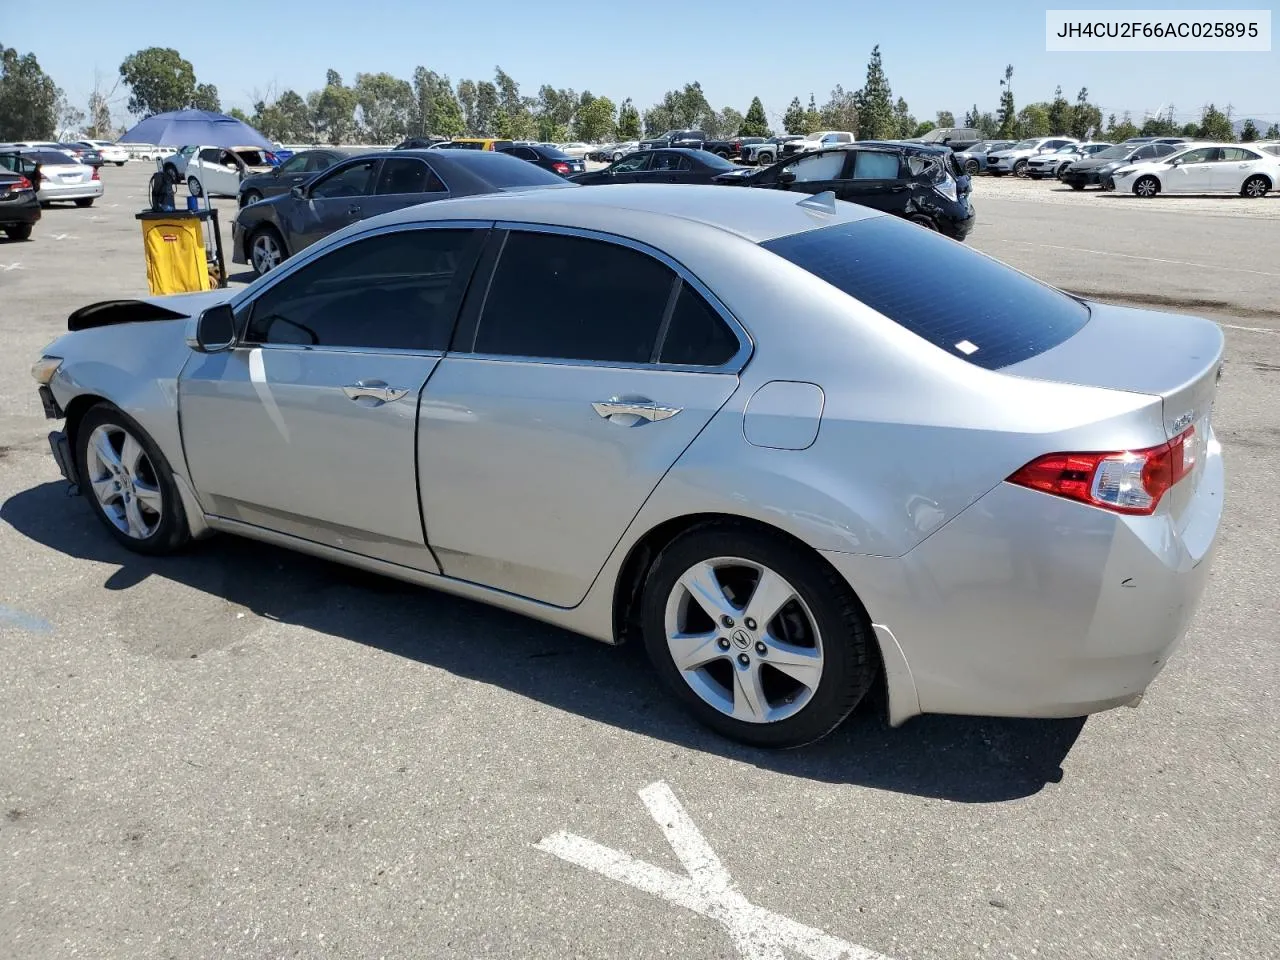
[86,424,164,540]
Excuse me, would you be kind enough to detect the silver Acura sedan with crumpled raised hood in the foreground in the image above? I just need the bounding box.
[33,184,1224,746]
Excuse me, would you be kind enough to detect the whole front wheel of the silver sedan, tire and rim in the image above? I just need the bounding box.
[76,403,191,554]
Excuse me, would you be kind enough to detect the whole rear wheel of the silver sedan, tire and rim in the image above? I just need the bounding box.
[640,522,878,748]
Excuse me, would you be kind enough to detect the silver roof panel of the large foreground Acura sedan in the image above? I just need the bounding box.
[360,183,884,243]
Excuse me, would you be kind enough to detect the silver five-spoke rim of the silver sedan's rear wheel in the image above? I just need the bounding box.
[664,557,823,723]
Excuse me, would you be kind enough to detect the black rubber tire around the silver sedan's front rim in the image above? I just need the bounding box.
[74,402,191,556]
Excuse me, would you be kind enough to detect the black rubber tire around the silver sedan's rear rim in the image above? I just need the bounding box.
[640,521,879,749]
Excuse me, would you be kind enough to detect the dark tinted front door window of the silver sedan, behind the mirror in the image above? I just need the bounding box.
[244,229,480,351]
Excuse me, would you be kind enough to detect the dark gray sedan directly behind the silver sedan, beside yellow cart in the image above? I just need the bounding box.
[232,148,576,276]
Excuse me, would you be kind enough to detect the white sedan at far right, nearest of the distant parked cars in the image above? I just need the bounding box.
[1111,143,1280,198]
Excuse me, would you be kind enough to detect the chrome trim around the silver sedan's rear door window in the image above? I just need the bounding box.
[455,220,755,374]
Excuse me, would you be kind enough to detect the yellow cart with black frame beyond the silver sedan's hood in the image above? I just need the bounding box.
[134,209,227,296]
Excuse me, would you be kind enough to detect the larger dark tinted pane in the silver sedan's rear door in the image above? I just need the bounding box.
[475,232,676,364]
